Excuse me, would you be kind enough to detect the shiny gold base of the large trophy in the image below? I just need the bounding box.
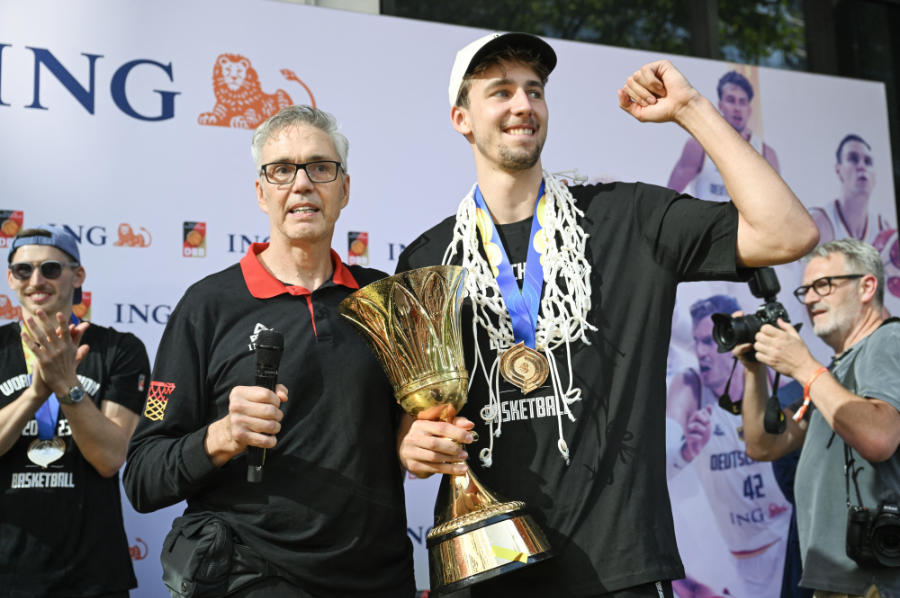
[426,501,553,593]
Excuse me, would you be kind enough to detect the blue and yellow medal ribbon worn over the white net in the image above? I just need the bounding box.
[474,180,544,349]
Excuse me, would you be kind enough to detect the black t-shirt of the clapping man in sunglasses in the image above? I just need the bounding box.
[0,323,150,598]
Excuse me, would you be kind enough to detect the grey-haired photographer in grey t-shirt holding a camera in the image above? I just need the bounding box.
[734,239,900,598]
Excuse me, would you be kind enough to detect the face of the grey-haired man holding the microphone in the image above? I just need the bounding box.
[256,125,350,247]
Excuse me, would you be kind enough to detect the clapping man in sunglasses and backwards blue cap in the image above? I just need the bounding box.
[0,225,150,598]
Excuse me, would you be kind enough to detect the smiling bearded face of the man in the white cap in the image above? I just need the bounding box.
[450,61,548,172]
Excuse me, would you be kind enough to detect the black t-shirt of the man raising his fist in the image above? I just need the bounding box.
[397,183,738,596]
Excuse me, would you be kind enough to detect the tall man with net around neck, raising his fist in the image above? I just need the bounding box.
[398,33,817,597]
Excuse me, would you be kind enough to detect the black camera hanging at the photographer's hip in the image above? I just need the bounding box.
[847,501,900,568]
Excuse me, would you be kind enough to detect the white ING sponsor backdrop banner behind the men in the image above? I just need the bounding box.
[0,0,900,597]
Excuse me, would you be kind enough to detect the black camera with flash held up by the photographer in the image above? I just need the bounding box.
[711,268,791,357]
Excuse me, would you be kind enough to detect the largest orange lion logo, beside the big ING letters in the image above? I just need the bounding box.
[197,54,316,129]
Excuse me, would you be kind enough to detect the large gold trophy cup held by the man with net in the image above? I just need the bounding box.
[338,266,552,592]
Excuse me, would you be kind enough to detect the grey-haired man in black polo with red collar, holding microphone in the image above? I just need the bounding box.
[124,106,415,598]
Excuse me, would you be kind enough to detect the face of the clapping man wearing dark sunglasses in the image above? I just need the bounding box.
[6,245,85,318]
